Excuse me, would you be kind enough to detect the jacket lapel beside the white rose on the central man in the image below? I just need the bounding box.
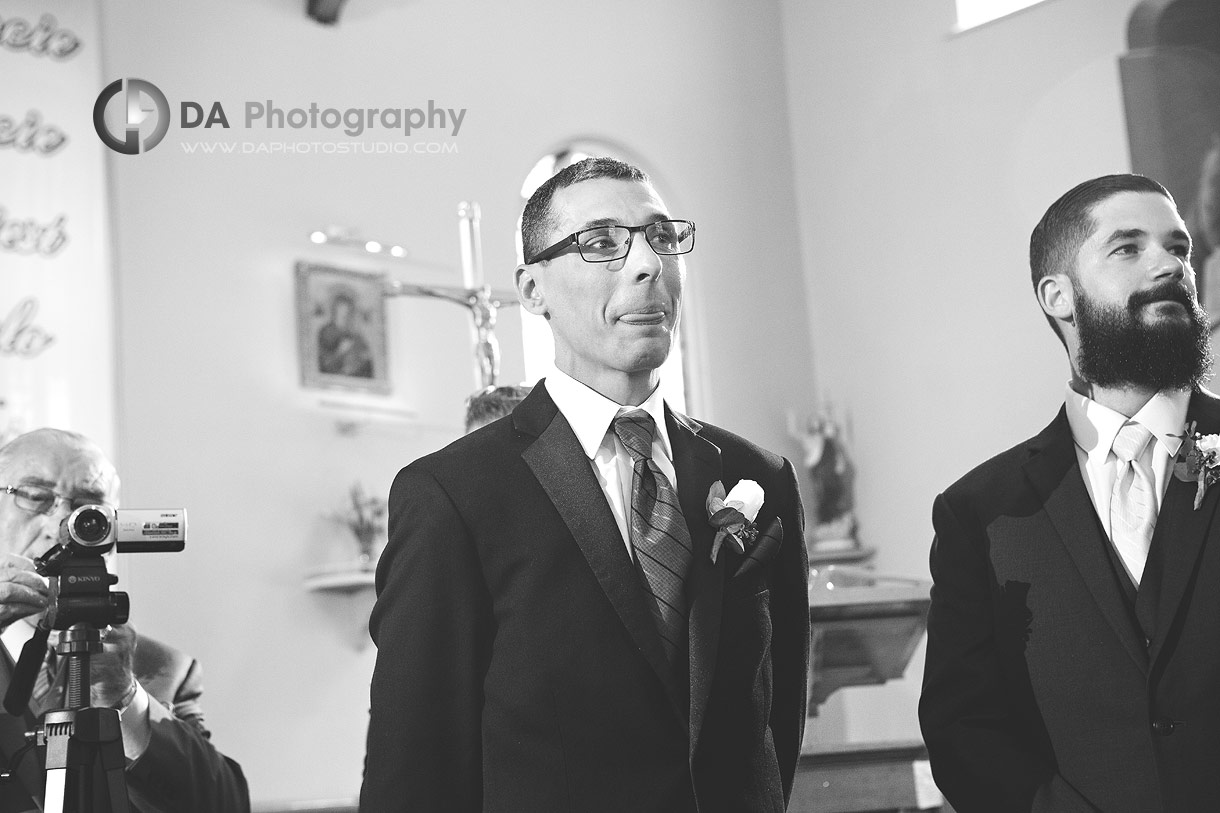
[666,409,726,757]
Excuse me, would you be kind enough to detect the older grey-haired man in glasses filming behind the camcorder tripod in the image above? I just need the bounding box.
[0,428,250,813]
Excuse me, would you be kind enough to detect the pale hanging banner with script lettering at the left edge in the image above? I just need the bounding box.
[0,0,115,452]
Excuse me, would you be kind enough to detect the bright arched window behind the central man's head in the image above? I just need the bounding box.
[516,139,692,413]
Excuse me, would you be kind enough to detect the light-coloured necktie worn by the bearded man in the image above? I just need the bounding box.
[1110,421,1157,587]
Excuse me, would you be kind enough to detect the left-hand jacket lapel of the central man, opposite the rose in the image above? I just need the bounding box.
[512,382,688,719]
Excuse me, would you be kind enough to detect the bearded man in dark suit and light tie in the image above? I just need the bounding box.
[920,175,1220,813]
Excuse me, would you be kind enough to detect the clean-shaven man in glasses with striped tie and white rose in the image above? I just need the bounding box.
[361,159,809,813]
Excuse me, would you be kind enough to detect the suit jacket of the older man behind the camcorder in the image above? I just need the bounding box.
[0,636,250,813]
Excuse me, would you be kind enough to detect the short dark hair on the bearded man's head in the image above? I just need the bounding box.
[1030,173,1177,342]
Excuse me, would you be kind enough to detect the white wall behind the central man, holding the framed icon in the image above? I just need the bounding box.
[102,0,814,801]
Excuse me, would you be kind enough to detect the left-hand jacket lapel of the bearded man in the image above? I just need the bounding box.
[1025,409,1148,669]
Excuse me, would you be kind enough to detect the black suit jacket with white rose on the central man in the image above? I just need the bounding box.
[361,385,809,813]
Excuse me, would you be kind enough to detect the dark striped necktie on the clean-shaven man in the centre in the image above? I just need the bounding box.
[614,409,692,667]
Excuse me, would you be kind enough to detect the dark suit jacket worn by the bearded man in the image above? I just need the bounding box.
[920,393,1220,813]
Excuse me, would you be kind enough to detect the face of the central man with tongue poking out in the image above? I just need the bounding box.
[533,178,686,388]
